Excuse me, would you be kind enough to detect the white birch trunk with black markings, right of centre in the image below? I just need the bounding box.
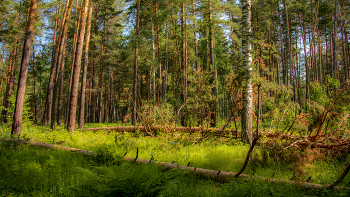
[241,0,254,144]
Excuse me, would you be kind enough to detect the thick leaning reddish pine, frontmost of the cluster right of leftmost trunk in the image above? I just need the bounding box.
[68,0,89,132]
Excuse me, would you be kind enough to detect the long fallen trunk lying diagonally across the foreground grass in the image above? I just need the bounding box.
[2,138,350,190]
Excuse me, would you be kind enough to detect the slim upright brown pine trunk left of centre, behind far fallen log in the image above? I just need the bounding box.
[131,0,140,126]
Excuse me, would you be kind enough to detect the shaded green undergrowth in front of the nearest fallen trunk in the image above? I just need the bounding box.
[0,141,347,196]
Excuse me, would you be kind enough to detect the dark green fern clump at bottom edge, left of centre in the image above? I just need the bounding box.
[76,163,181,196]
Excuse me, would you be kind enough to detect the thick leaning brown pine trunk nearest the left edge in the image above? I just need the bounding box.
[11,0,38,136]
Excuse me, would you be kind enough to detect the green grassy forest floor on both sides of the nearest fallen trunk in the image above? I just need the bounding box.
[0,125,350,196]
